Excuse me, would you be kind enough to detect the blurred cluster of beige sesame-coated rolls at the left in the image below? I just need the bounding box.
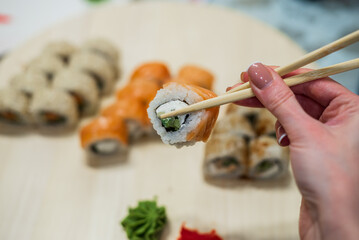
[0,39,119,130]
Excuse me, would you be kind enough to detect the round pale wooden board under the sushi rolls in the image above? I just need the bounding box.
[0,3,310,240]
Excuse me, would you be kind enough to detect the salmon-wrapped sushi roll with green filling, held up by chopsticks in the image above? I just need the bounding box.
[147,82,219,147]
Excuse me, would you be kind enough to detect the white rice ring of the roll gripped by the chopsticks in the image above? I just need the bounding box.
[147,82,206,148]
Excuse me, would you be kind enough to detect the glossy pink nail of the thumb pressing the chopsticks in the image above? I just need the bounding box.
[248,63,273,89]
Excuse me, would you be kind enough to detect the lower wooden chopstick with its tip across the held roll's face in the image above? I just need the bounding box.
[159,58,359,119]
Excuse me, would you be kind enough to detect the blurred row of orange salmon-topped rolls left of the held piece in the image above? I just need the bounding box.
[80,62,171,156]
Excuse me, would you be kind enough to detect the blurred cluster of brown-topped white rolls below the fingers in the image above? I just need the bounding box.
[203,105,289,180]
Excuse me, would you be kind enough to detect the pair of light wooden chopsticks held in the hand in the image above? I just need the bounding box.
[160,30,359,119]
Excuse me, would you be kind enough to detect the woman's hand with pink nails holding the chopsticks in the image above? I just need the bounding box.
[229,63,359,239]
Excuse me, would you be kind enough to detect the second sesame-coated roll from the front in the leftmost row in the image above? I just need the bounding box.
[10,69,50,98]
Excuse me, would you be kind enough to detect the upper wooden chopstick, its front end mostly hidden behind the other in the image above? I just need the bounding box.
[228,30,359,94]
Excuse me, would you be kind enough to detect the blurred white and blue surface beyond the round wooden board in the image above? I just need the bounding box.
[0,0,359,94]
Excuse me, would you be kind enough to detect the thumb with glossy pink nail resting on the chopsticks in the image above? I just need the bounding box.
[248,63,312,139]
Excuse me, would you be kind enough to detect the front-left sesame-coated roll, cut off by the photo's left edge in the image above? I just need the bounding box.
[0,88,29,125]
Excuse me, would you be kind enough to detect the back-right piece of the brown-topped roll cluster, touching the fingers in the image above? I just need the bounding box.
[254,109,277,138]
